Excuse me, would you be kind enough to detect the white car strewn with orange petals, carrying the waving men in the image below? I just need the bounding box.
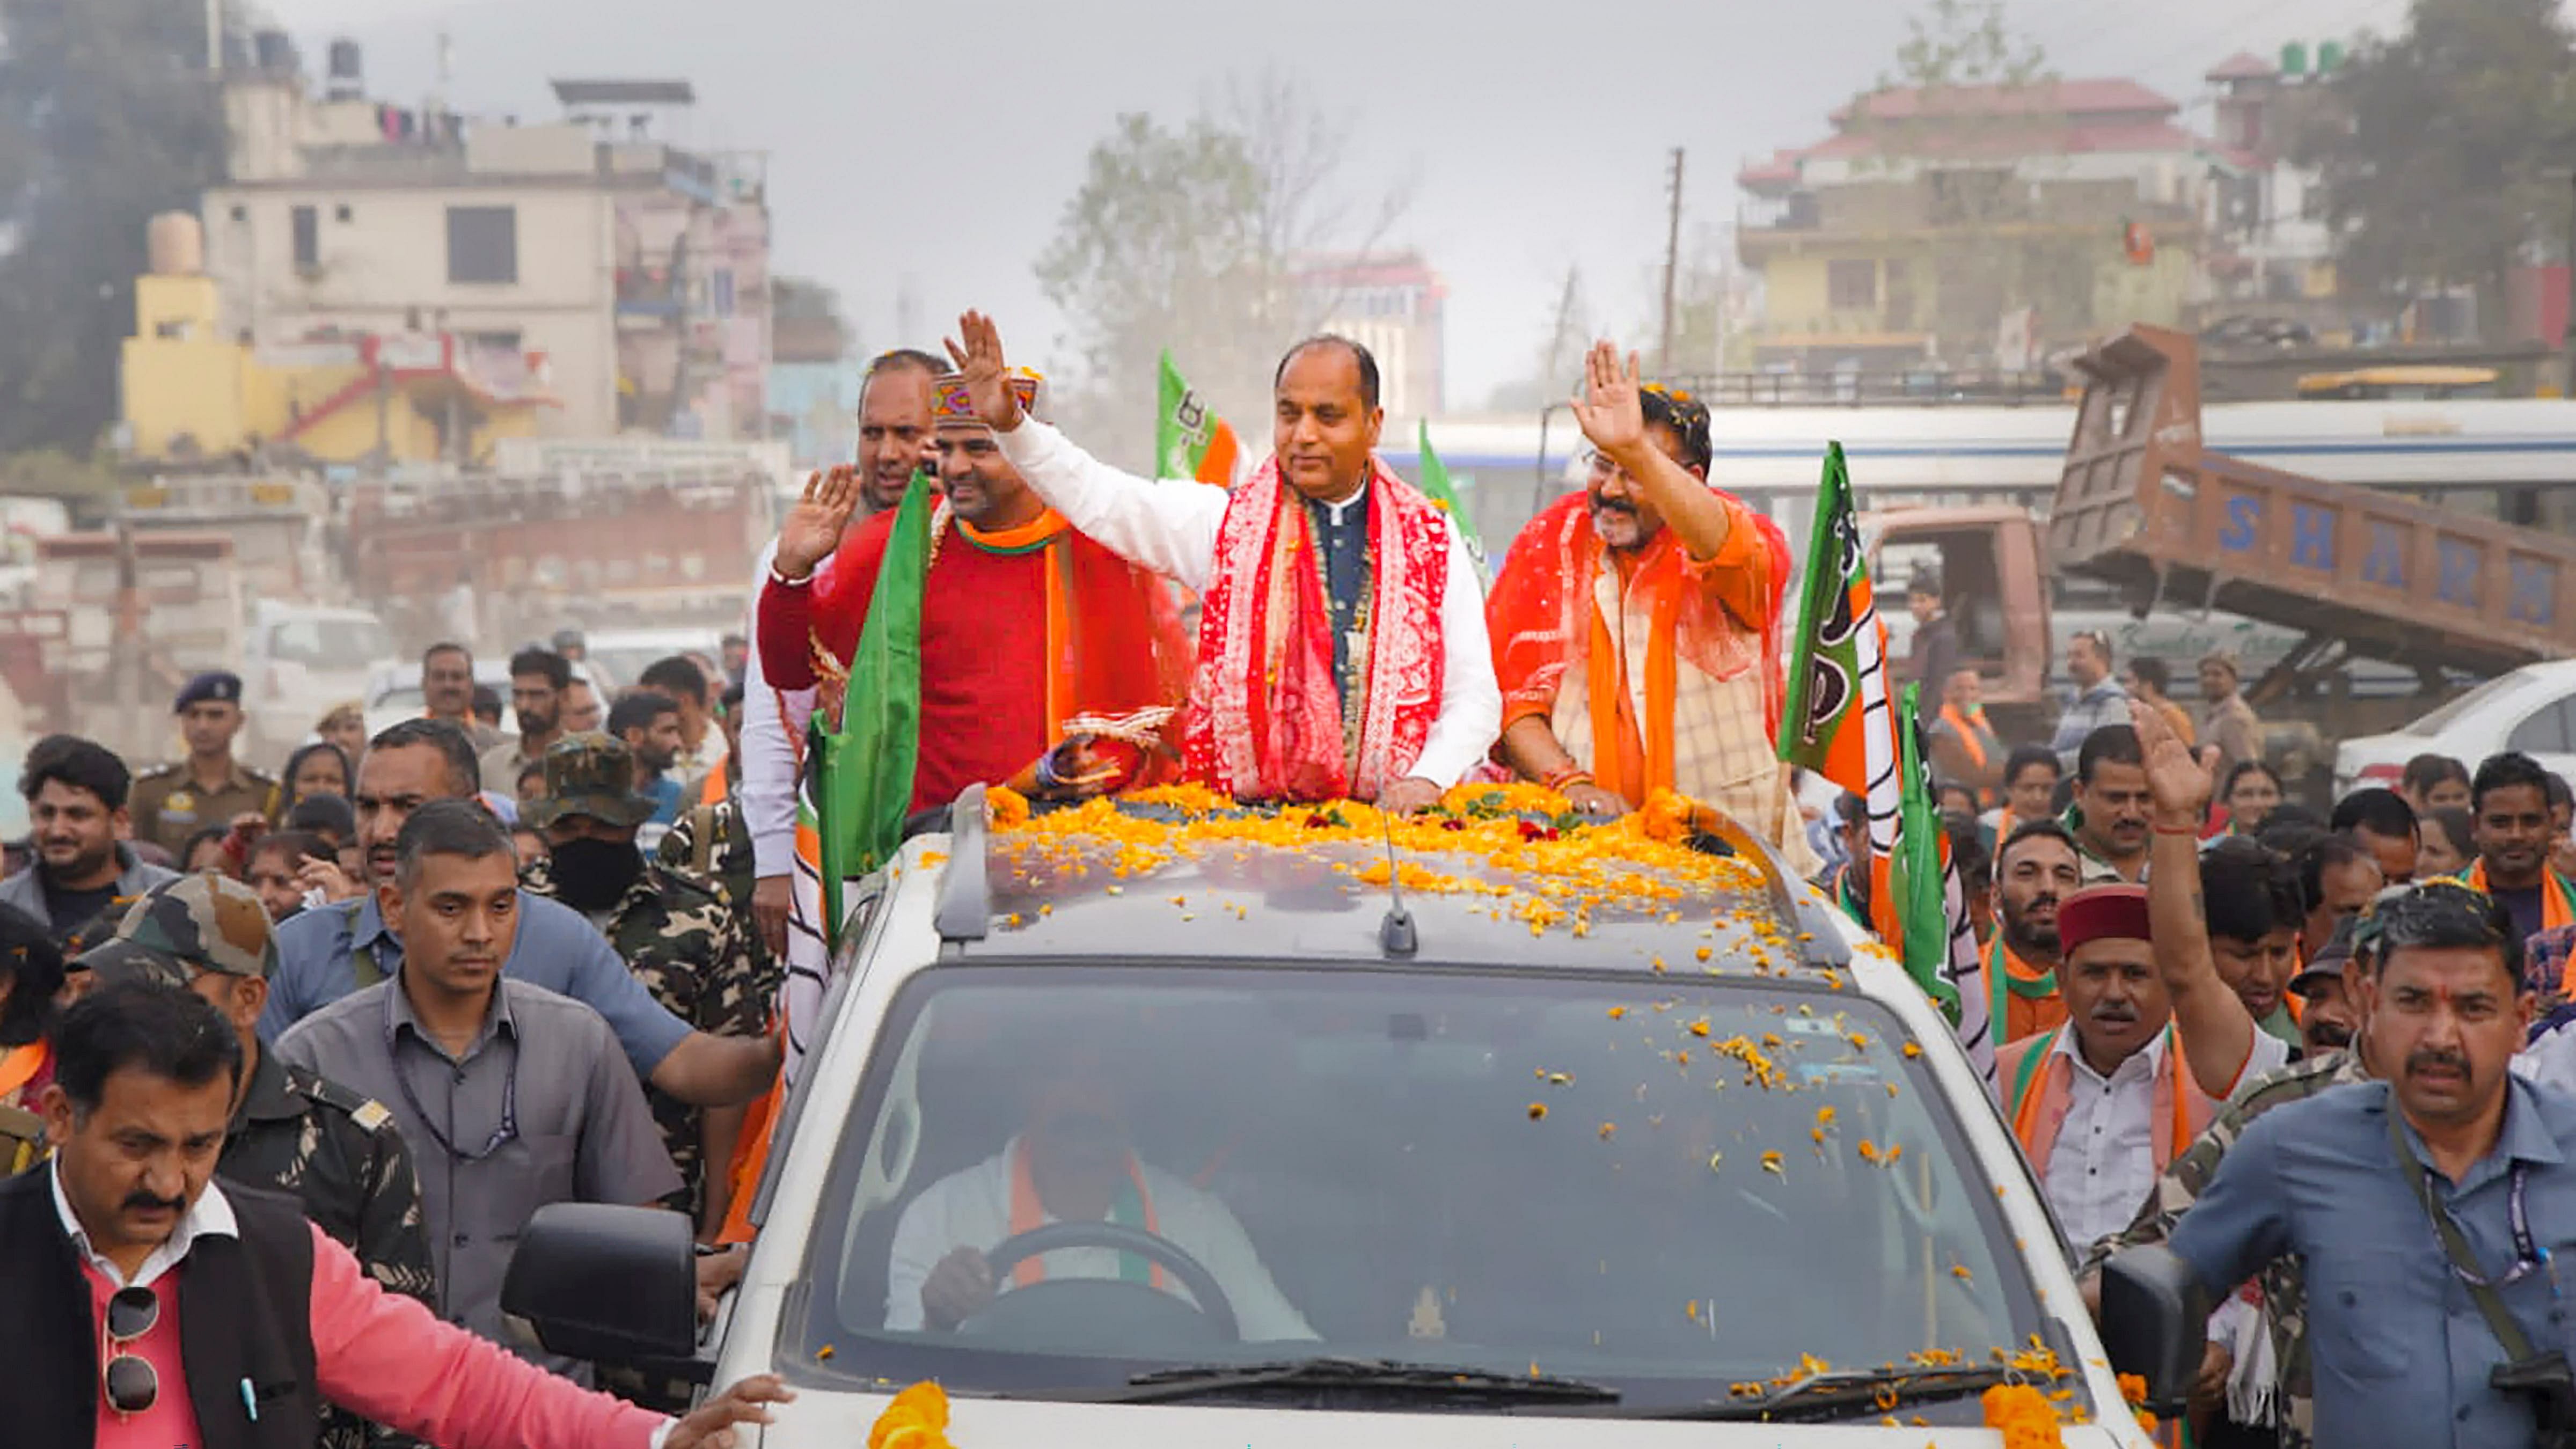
[502,789,2153,1449]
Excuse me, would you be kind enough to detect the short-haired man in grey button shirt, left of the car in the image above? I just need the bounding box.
[278,799,680,1372]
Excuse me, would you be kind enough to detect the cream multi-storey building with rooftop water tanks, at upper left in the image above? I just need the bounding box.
[203,36,770,446]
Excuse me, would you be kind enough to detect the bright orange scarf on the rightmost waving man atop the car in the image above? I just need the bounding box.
[1487,493,1790,799]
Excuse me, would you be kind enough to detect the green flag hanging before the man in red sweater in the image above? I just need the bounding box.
[814,472,930,928]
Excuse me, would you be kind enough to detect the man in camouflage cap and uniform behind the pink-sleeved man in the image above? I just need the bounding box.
[80,872,438,1449]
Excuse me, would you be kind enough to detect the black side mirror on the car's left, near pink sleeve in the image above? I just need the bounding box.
[500,1202,698,1364]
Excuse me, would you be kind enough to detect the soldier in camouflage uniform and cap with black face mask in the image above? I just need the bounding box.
[521,735,767,1243]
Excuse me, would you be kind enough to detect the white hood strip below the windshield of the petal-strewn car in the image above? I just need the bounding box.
[760,1387,2146,1449]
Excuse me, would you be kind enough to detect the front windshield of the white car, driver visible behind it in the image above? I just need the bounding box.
[780,964,2050,1423]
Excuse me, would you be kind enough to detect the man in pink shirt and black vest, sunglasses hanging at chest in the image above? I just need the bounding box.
[0,985,793,1449]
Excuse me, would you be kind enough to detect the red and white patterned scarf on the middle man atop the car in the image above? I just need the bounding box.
[1182,459,1450,799]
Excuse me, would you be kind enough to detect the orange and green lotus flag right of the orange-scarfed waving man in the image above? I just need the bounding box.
[1780,443,1994,1080]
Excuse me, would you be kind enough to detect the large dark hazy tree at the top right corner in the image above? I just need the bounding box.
[2293,0,2576,307]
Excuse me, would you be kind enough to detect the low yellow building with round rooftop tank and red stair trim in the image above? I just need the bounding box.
[121,214,554,464]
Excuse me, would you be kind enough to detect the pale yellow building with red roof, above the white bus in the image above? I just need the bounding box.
[1736,80,2210,371]
